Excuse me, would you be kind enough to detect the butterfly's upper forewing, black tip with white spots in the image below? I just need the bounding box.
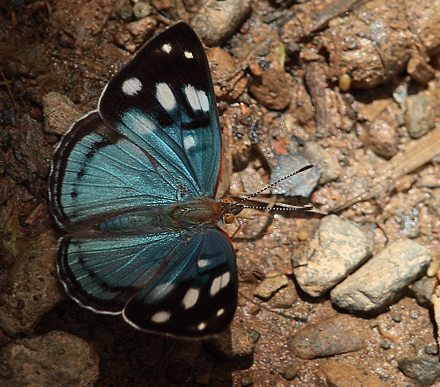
[99,23,221,198]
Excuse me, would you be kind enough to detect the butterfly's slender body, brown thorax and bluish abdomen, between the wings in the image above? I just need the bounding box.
[96,198,222,233]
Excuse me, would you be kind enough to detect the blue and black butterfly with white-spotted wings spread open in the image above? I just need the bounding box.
[49,22,242,338]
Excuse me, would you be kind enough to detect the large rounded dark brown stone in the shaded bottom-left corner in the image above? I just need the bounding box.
[0,331,99,387]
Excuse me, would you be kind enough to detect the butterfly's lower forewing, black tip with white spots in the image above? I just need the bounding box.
[124,229,237,338]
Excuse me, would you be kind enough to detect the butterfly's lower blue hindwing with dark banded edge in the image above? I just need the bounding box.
[58,232,184,314]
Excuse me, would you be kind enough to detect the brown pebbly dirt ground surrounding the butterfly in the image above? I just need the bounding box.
[0,0,440,387]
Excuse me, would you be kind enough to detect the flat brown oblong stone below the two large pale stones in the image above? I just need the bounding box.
[288,315,370,359]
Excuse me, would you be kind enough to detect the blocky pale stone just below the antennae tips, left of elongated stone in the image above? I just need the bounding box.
[294,215,372,297]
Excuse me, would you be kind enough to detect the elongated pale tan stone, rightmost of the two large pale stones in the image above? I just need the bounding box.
[330,239,431,313]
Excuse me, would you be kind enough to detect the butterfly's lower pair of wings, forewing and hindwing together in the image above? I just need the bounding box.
[58,228,237,338]
